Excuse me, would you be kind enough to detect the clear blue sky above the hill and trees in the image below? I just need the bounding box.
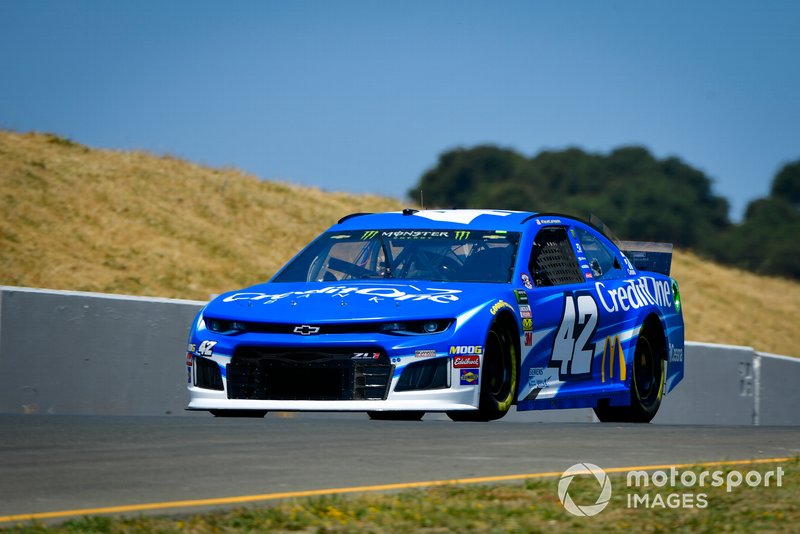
[0,0,800,217]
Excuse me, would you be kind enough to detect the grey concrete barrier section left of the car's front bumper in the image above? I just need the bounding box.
[0,287,204,415]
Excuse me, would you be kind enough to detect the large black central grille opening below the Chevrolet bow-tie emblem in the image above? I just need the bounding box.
[226,347,394,400]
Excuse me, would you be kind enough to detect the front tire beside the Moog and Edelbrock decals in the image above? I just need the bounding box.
[447,323,519,421]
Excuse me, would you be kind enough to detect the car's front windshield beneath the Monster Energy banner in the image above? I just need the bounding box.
[272,230,519,283]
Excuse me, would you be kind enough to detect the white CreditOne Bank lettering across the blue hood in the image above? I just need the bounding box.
[223,285,461,304]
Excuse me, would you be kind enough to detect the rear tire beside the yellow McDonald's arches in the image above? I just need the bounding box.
[594,324,666,423]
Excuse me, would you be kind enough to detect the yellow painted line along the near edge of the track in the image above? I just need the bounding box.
[0,457,795,523]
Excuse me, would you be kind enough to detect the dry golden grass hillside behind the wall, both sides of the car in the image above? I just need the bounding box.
[0,130,800,355]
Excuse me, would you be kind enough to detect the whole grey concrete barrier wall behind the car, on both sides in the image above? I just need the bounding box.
[0,286,800,425]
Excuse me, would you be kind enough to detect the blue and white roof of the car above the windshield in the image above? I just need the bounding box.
[330,209,544,232]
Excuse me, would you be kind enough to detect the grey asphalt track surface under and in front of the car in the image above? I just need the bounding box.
[0,414,800,526]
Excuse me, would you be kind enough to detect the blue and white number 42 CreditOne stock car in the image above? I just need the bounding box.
[186,209,684,422]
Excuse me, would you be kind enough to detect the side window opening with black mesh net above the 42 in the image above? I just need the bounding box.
[529,226,584,287]
